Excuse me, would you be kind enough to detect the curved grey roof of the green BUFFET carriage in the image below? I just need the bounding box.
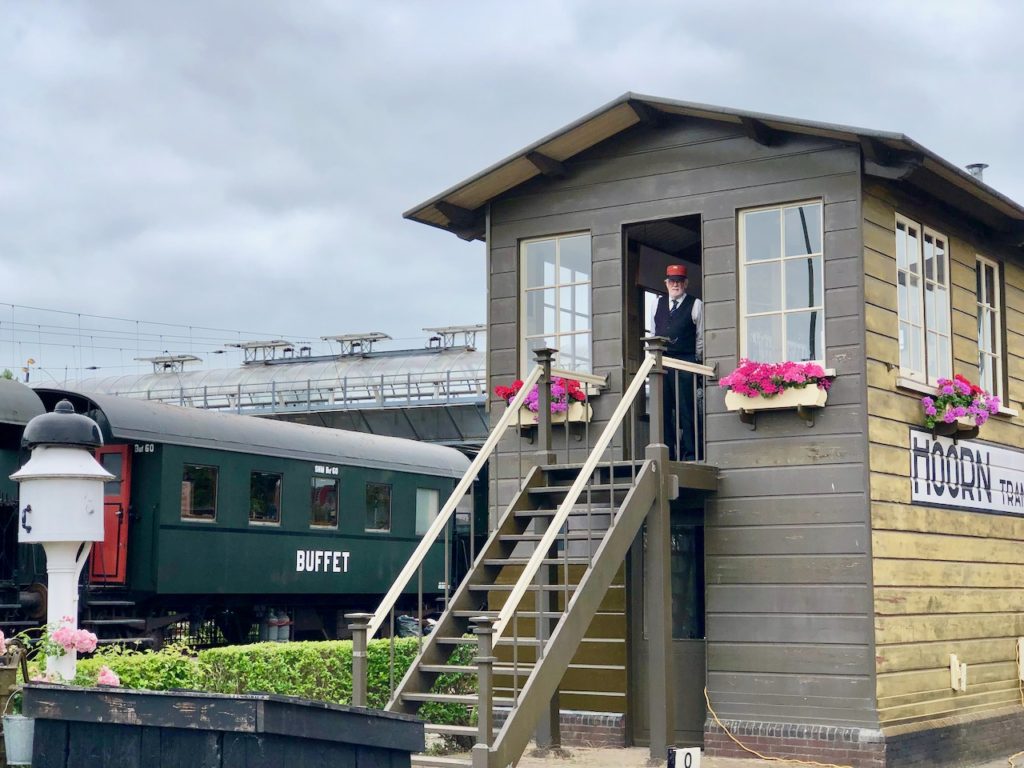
[37,388,469,477]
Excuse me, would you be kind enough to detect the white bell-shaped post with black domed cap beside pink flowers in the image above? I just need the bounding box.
[10,400,114,680]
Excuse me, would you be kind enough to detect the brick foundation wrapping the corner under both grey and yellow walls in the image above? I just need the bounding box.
[705,707,1024,768]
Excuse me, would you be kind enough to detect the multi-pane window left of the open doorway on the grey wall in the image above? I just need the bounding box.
[520,232,593,371]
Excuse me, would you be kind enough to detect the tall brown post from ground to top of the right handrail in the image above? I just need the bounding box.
[644,337,676,764]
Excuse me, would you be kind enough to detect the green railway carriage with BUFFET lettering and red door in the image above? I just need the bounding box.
[3,389,469,642]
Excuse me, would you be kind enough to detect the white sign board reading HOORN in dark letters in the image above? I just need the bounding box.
[910,429,1024,515]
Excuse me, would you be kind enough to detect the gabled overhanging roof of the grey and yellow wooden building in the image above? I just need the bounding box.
[403,93,1024,247]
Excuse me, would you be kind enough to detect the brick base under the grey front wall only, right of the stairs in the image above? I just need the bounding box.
[705,720,886,768]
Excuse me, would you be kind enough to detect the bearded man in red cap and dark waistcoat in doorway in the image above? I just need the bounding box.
[651,264,703,461]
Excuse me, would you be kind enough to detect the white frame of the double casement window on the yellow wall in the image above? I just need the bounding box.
[893,213,953,386]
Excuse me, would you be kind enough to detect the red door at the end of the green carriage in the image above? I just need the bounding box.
[89,445,131,584]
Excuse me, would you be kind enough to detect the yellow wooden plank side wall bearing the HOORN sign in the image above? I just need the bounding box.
[862,186,1024,727]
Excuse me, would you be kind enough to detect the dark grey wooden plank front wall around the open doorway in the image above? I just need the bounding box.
[488,119,876,725]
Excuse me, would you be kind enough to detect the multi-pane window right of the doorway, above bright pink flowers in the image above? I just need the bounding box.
[739,203,825,362]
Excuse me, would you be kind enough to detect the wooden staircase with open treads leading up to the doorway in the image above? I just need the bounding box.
[387,461,659,767]
